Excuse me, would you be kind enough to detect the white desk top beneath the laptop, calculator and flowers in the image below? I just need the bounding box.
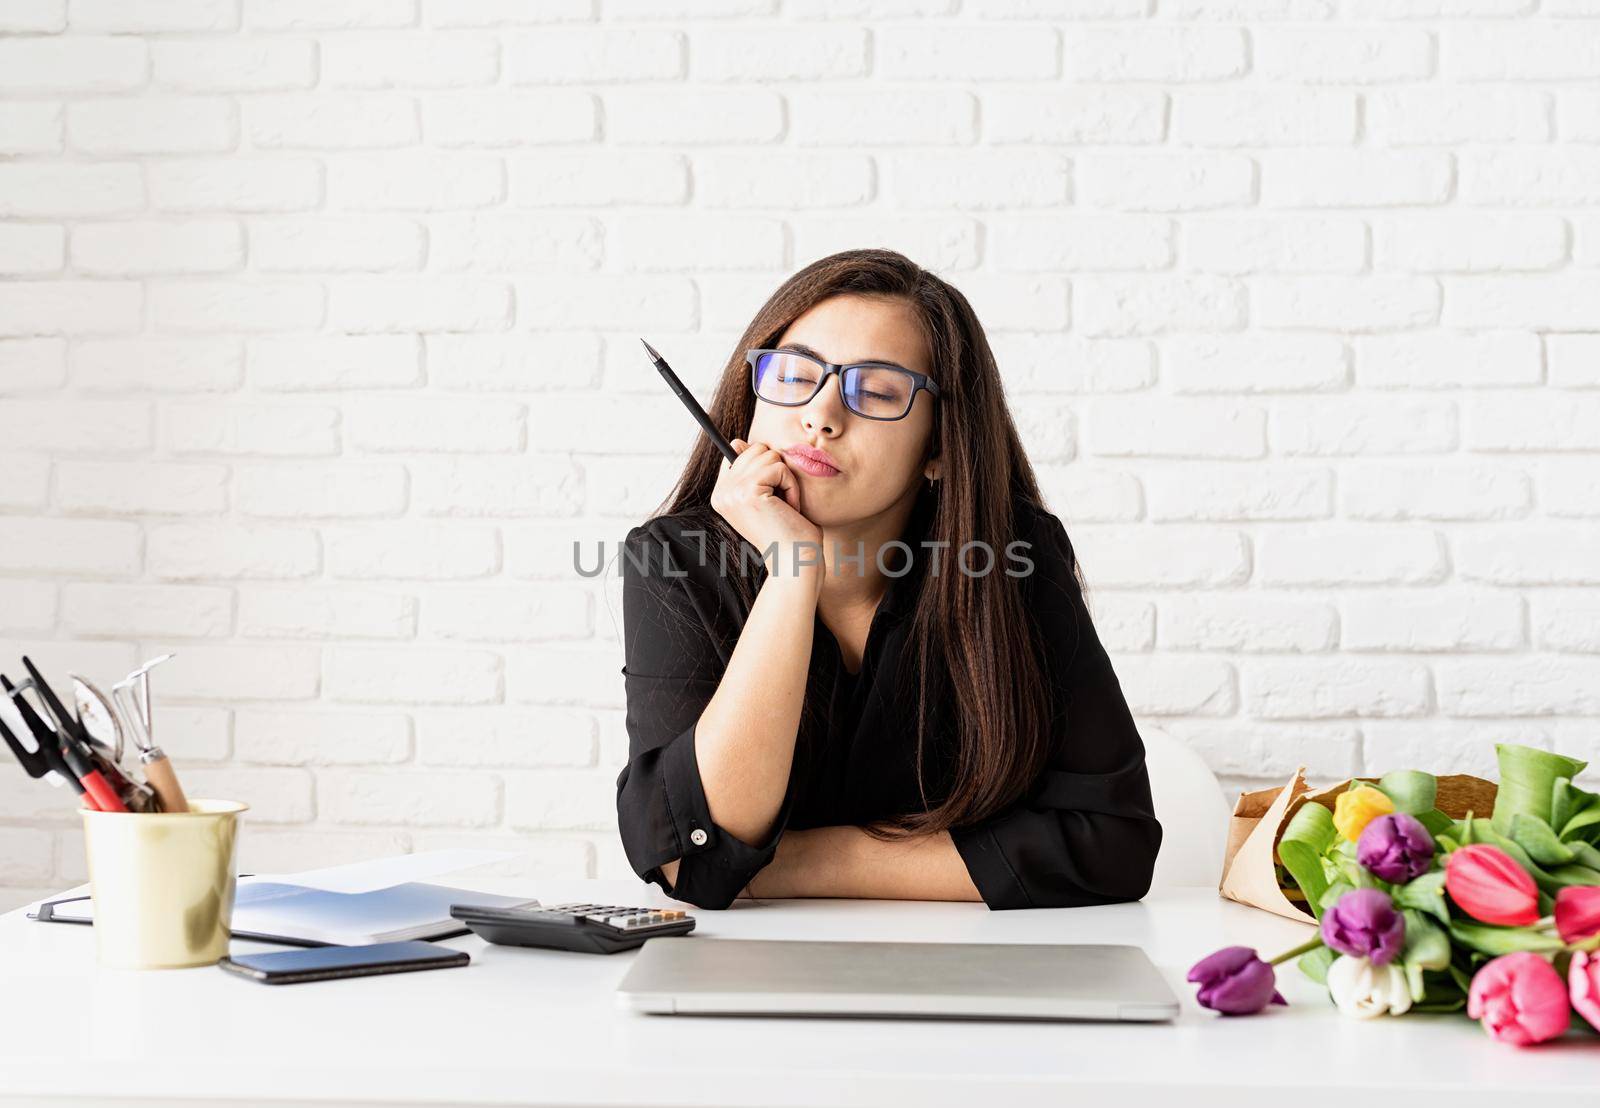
[0,881,1600,1108]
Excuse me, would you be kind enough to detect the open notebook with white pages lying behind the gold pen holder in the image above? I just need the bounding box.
[32,877,528,946]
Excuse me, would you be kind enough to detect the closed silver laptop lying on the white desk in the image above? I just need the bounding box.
[616,935,1178,1020]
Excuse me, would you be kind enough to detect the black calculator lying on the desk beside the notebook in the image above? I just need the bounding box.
[450,900,694,954]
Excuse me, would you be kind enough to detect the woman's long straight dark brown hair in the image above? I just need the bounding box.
[658,250,1082,839]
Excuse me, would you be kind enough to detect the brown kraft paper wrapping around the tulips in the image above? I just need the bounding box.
[1218,765,1498,924]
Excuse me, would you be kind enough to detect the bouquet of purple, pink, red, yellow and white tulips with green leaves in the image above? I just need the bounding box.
[1189,743,1600,1046]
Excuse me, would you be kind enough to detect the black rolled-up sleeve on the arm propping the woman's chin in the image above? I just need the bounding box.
[616,524,795,908]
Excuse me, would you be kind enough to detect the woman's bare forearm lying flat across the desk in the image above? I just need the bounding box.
[744,826,982,901]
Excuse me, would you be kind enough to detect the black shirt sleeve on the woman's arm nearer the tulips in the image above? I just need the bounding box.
[950,512,1162,909]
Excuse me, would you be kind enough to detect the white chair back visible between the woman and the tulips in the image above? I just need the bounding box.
[1139,727,1234,889]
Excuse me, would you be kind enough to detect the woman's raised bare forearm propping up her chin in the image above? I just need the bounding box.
[688,567,822,845]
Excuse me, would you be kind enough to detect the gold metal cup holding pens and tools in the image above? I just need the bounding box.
[82,801,248,969]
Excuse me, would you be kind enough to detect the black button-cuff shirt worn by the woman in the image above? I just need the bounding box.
[616,490,1162,908]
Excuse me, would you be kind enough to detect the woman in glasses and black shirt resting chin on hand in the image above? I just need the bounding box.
[618,250,1162,908]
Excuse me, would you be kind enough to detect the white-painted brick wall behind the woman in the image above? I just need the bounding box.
[0,0,1600,906]
